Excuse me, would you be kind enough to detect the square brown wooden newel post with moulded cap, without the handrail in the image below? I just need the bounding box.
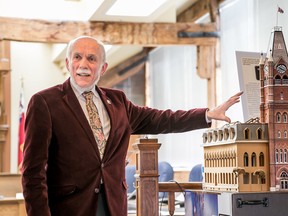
[133,139,161,216]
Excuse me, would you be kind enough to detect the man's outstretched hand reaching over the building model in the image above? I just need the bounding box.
[207,91,243,123]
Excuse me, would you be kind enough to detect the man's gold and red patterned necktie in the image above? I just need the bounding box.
[83,91,106,158]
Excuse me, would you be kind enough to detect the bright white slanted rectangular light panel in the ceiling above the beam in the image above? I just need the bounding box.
[106,0,167,16]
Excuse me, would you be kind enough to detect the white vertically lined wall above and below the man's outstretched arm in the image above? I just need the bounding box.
[149,46,207,169]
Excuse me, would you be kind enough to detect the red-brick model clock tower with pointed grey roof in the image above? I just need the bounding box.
[259,27,288,191]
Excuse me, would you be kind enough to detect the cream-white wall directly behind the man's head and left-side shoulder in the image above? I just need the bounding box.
[11,42,66,172]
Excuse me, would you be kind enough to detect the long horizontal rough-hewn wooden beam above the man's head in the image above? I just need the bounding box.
[0,17,217,46]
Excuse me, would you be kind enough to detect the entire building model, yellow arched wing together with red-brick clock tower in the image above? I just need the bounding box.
[203,27,288,192]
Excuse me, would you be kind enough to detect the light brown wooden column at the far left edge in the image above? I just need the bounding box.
[0,40,11,172]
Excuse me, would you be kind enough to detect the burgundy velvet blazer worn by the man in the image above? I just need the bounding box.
[22,79,210,216]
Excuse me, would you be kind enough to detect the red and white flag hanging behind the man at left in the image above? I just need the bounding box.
[18,89,25,173]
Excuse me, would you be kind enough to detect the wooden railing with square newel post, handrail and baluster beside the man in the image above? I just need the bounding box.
[133,139,202,216]
